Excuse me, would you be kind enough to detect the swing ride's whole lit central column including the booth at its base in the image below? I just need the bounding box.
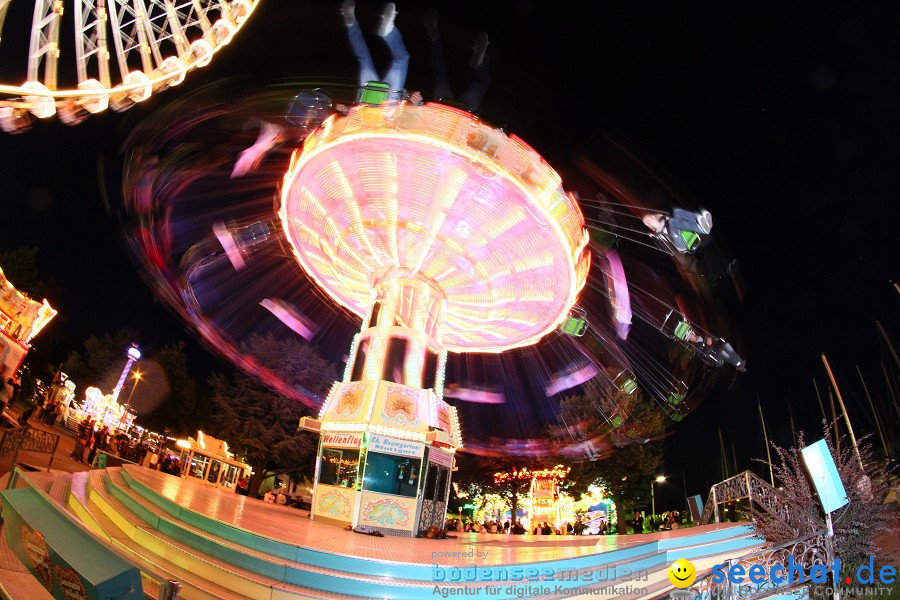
[301,268,461,536]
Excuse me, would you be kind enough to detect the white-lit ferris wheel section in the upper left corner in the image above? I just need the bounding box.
[0,0,259,133]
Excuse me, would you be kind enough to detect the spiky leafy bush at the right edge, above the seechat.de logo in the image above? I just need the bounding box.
[751,421,897,573]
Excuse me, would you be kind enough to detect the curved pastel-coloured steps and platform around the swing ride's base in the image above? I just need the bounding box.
[5,466,761,600]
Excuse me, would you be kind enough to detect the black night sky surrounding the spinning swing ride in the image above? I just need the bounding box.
[0,0,900,506]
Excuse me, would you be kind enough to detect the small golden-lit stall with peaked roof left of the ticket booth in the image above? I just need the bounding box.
[176,431,252,491]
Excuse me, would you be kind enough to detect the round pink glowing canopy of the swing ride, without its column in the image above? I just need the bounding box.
[280,104,590,352]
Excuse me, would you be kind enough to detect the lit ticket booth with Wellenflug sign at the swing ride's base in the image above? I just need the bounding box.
[303,382,458,536]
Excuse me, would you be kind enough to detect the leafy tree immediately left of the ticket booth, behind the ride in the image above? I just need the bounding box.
[209,334,337,496]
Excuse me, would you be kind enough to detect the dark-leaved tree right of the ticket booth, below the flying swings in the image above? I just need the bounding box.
[561,387,665,533]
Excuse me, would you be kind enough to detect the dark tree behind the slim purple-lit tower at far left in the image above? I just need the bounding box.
[65,328,140,394]
